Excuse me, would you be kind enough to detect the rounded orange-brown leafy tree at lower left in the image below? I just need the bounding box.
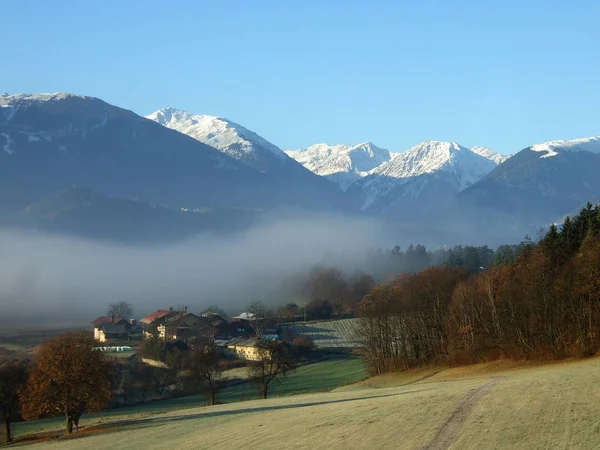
[22,332,112,434]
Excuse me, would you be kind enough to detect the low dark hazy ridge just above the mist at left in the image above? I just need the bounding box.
[0,187,253,243]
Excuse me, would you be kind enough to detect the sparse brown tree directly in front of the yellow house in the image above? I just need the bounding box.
[248,338,297,399]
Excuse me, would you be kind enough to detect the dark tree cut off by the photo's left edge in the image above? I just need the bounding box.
[0,359,27,444]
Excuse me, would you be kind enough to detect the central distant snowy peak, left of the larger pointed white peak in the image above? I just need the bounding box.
[285,142,394,191]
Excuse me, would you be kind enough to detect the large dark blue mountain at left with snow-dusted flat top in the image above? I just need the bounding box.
[0,93,338,214]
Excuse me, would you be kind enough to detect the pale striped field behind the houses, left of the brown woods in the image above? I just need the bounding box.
[286,319,359,348]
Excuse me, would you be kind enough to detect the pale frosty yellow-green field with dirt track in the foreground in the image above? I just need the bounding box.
[15,359,600,449]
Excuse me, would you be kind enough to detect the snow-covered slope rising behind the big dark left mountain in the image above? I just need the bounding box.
[146,108,289,170]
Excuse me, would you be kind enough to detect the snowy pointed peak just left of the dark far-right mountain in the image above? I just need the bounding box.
[352,141,497,210]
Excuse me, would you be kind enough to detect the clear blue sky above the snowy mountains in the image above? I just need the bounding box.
[0,0,600,153]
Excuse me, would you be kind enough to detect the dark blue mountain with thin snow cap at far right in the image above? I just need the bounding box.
[458,137,600,225]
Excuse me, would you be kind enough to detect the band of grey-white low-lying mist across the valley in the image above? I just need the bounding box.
[0,216,397,325]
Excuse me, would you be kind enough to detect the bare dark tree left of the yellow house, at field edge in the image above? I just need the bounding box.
[189,341,223,405]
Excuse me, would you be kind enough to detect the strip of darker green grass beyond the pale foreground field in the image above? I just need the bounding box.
[14,355,367,436]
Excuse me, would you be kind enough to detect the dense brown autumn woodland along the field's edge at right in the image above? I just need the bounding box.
[357,203,600,374]
